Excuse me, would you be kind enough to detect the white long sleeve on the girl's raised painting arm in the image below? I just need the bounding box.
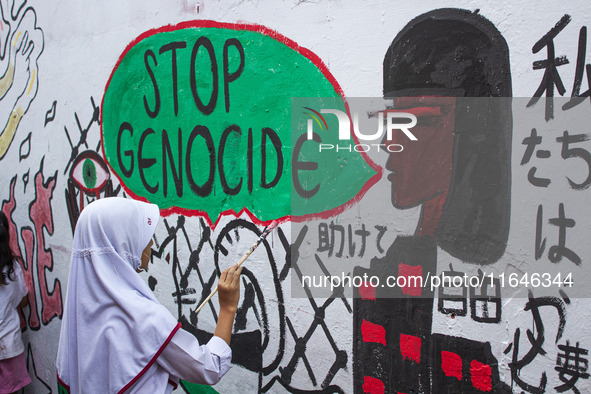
[125,329,232,394]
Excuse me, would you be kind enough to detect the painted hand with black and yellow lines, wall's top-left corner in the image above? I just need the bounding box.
[0,0,44,160]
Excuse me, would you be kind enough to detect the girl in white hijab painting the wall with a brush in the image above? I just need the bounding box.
[57,197,241,394]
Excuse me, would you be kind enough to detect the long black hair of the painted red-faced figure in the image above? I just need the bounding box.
[384,9,512,264]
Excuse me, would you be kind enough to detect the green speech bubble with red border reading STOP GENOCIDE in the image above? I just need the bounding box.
[101,21,375,222]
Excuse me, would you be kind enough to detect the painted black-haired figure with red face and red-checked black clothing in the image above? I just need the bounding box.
[353,9,512,393]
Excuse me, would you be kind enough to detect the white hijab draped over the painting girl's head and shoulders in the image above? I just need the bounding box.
[57,197,180,393]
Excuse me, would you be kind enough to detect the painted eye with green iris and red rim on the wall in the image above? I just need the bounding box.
[70,150,111,194]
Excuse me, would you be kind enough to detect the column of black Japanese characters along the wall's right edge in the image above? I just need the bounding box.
[504,14,591,393]
